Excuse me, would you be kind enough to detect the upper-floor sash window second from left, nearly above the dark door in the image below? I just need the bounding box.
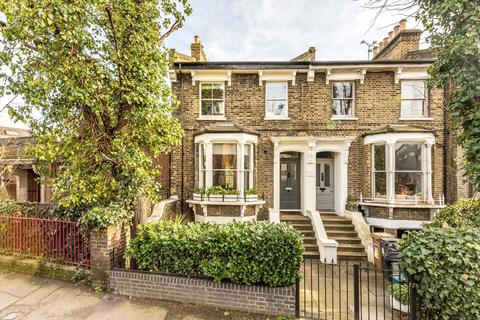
[265,82,288,120]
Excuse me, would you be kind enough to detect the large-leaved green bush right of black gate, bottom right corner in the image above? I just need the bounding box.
[400,228,480,320]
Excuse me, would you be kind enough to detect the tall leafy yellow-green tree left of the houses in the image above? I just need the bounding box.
[0,0,191,227]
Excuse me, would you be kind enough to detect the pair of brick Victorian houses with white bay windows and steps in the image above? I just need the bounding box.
[170,20,468,257]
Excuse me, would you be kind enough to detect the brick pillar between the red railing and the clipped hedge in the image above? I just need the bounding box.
[90,223,130,286]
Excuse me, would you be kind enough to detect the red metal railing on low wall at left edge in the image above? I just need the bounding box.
[0,216,90,267]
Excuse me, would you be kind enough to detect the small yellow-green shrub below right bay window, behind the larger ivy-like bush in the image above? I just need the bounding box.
[429,198,480,228]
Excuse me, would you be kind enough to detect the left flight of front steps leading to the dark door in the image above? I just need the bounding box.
[280,212,320,259]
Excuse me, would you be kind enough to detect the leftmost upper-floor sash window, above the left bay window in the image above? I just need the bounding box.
[200,82,225,119]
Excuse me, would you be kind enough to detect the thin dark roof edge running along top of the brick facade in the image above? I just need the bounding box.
[173,59,434,70]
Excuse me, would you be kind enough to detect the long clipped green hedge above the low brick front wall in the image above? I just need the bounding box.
[126,220,303,286]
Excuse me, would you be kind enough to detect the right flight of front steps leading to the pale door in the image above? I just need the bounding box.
[320,213,367,261]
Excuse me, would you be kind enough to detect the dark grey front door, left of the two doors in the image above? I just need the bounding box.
[280,152,300,210]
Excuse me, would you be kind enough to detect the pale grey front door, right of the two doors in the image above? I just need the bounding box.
[316,158,334,210]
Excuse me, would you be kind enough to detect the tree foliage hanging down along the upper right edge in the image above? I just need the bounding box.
[413,0,480,189]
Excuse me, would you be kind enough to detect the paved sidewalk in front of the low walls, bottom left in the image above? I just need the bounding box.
[0,270,275,320]
